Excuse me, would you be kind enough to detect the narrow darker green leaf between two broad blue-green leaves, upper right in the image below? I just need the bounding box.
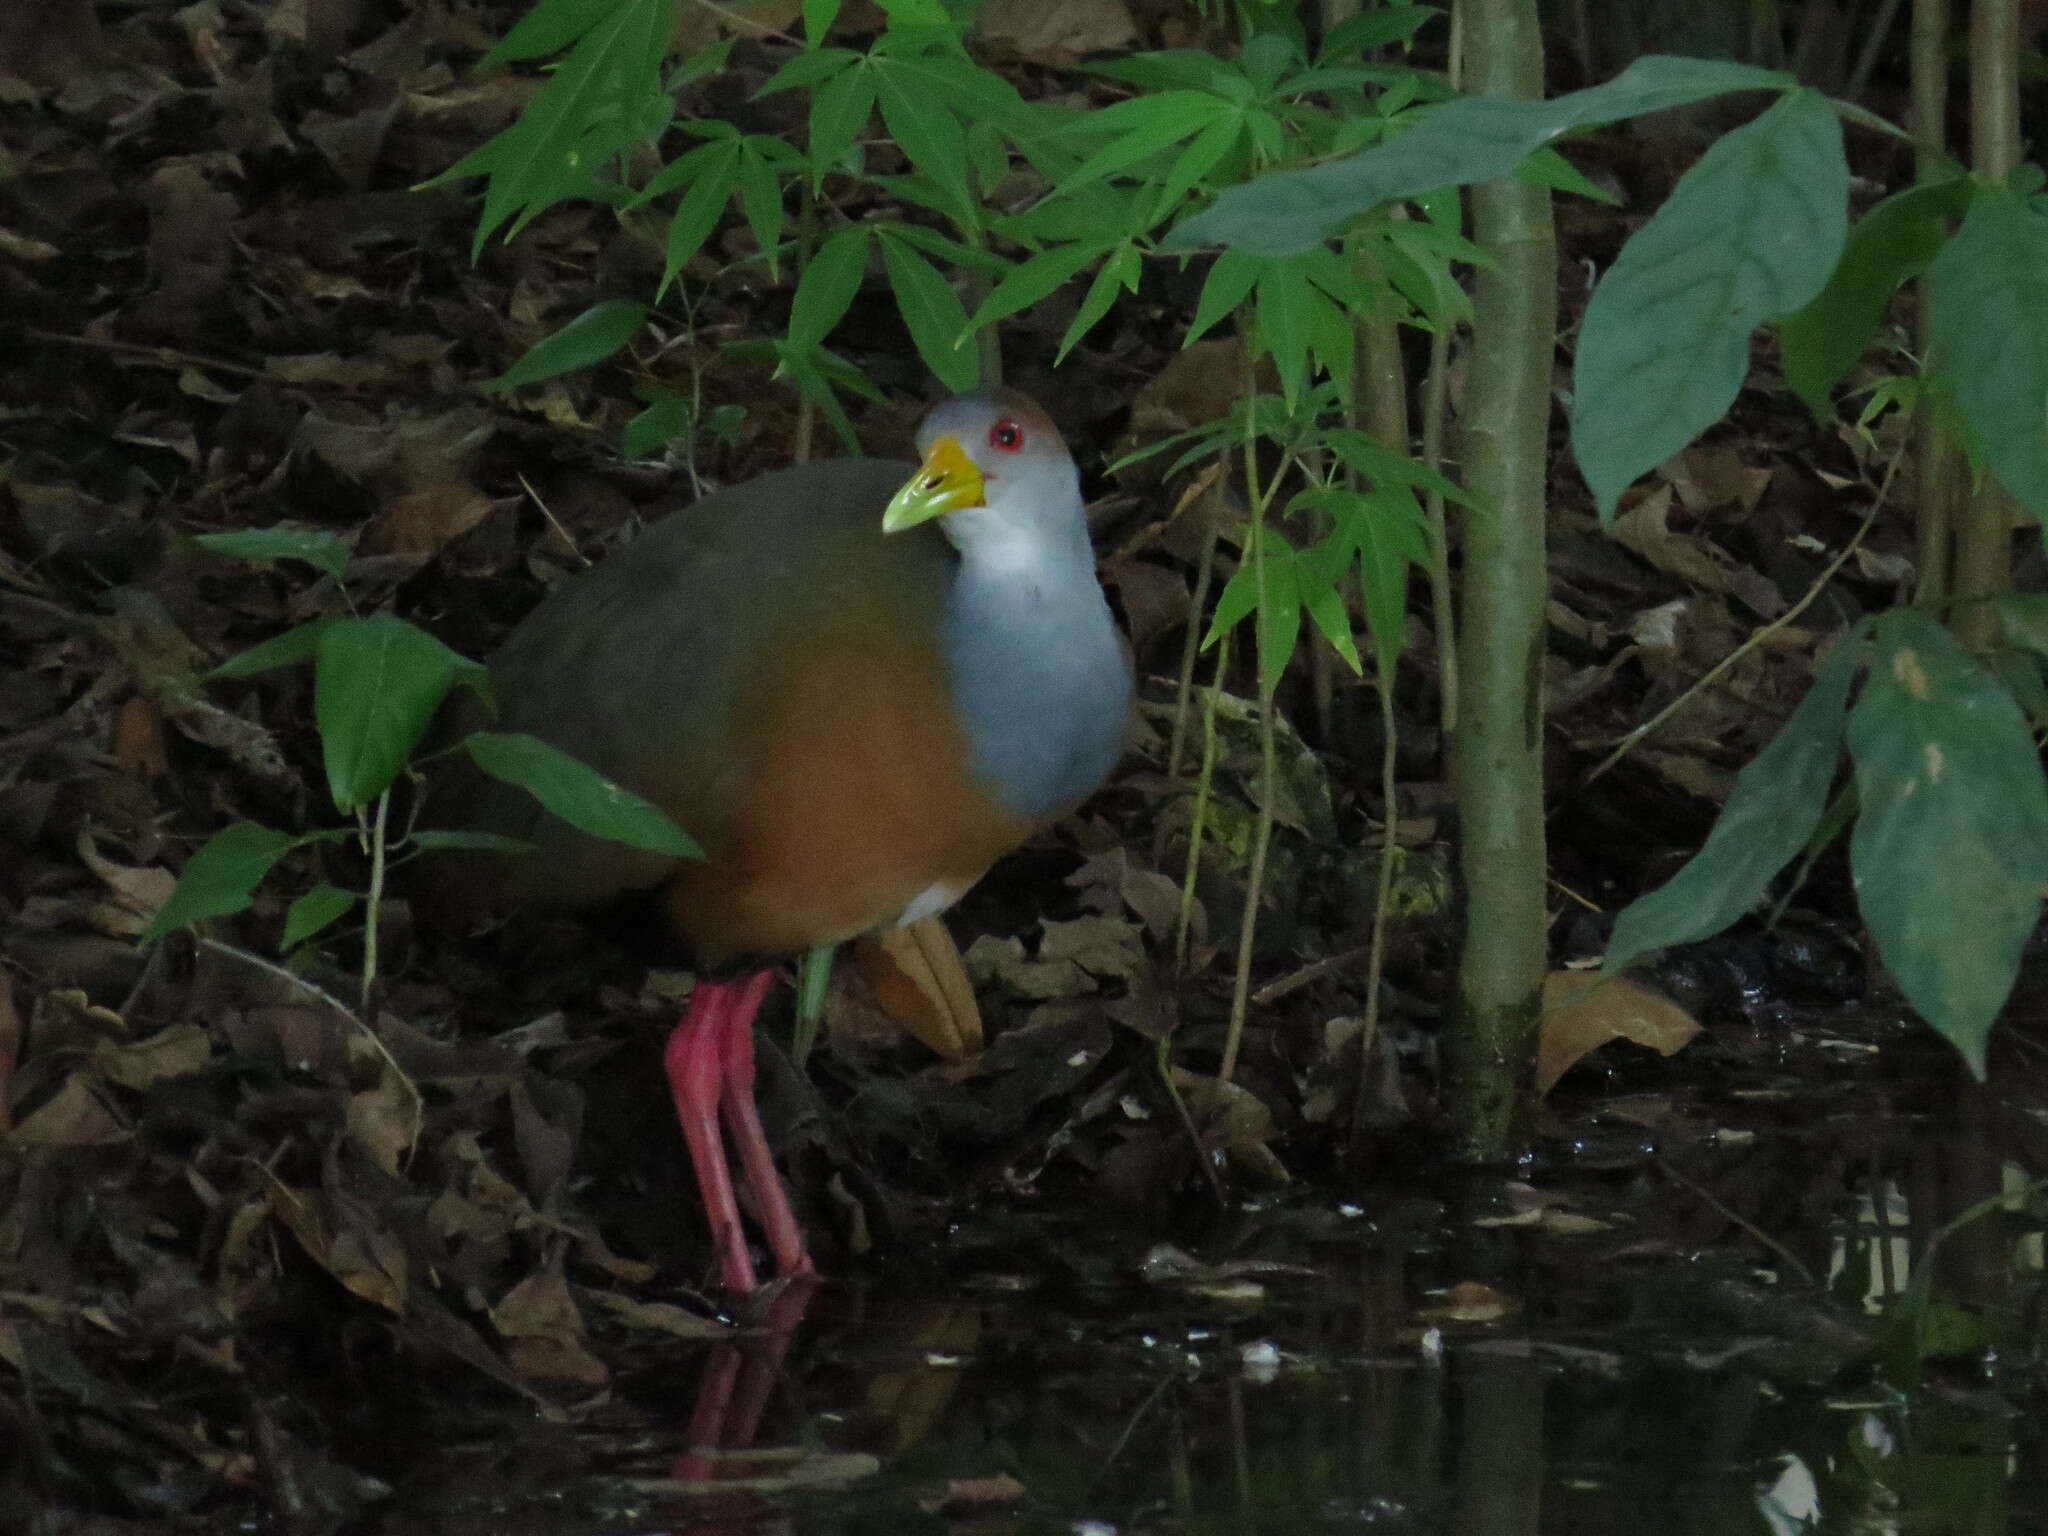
[1778,176,1970,420]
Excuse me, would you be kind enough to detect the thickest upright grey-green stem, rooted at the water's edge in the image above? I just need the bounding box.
[1448,0,1556,1161]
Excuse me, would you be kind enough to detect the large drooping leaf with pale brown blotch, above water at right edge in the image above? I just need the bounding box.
[1849,608,2048,1077]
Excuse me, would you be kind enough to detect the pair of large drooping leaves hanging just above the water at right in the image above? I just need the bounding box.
[1608,608,2048,1073]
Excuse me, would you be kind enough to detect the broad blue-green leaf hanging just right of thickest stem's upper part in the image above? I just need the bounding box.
[1571,90,1849,518]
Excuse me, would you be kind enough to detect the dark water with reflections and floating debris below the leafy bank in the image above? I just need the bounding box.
[356,1011,2048,1536]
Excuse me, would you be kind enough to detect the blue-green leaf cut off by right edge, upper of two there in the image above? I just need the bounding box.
[1927,186,2048,528]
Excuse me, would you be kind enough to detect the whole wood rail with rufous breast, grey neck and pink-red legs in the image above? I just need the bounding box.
[422,389,1130,1290]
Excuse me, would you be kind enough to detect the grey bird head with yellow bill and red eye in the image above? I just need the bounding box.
[883,389,1087,565]
